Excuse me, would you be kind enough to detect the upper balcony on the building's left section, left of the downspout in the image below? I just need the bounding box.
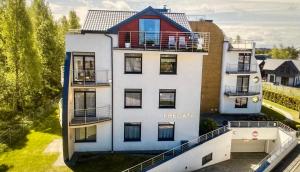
[71,70,112,87]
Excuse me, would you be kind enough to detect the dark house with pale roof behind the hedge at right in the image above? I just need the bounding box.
[262,59,300,87]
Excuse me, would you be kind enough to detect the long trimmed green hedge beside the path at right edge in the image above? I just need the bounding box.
[263,90,300,111]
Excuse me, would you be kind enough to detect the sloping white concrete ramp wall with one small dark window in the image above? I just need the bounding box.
[150,131,232,172]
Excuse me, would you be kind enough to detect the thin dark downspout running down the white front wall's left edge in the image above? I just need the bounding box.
[104,34,114,152]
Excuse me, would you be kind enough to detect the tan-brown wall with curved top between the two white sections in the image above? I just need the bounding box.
[189,21,224,113]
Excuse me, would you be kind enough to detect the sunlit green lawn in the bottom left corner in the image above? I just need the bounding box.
[0,131,68,172]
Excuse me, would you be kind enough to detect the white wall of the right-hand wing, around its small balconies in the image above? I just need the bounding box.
[220,42,262,114]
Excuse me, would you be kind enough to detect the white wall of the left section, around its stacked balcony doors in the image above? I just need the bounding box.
[66,34,112,157]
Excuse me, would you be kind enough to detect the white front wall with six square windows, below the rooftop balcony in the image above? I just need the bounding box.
[113,50,204,151]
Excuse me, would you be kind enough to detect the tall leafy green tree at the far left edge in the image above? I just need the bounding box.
[2,0,41,112]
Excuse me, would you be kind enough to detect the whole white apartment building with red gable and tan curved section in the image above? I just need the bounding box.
[62,7,262,160]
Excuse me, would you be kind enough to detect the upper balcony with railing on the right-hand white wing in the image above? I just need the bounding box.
[226,64,257,74]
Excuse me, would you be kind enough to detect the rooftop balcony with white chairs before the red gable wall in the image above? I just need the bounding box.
[115,31,210,52]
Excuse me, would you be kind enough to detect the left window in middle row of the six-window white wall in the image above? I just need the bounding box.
[124,89,142,108]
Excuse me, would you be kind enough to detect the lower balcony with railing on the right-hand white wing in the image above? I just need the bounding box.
[224,86,261,97]
